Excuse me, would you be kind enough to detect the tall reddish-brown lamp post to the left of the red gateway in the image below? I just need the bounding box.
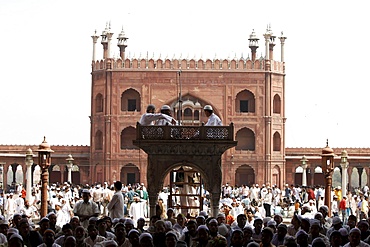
[37,137,54,218]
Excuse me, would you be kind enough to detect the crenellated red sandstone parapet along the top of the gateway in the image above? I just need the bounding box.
[92,59,284,73]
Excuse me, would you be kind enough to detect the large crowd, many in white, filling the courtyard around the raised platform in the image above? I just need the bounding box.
[0,181,370,247]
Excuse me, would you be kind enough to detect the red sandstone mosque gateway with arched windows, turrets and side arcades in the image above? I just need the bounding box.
[0,27,370,188]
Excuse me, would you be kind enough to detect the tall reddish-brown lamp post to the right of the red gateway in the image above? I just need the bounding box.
[321,140,335,217]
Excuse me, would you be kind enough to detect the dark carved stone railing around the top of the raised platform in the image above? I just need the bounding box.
[136,123,234,141]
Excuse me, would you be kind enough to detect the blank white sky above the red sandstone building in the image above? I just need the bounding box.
[0,0,370,148]
